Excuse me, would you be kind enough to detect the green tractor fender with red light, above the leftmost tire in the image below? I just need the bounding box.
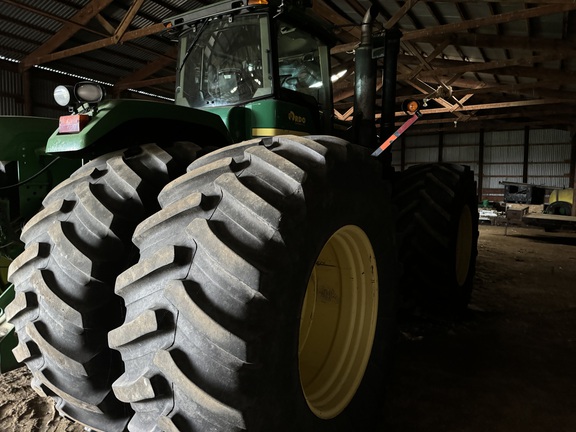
[46,99,232,159]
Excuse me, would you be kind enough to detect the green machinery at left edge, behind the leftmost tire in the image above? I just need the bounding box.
[0,116,80,373]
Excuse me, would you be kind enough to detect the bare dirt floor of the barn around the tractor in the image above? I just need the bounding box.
[0,225,576,432]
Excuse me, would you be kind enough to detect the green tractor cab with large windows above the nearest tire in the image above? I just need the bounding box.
[165,0,333,139]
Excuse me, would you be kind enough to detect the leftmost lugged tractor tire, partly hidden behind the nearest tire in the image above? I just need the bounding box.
[7,143,200,432]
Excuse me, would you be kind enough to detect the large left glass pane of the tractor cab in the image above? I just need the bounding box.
[176,15,272,108]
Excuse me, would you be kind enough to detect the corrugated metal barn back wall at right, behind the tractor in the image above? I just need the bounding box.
[392,129,576,201]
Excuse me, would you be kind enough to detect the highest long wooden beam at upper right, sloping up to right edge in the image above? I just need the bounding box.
[402,1,576,40]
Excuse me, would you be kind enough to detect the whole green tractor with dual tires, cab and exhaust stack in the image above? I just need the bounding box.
[7,0,477,432]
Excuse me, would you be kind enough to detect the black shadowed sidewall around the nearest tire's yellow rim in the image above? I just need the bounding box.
[256,177,397,431]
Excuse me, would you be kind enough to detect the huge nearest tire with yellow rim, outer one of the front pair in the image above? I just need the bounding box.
[109,136,396,432]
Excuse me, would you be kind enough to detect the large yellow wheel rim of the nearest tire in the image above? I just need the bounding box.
[298,225,378,419]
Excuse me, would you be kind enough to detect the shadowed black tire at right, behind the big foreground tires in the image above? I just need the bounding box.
[393,164,478,316]
